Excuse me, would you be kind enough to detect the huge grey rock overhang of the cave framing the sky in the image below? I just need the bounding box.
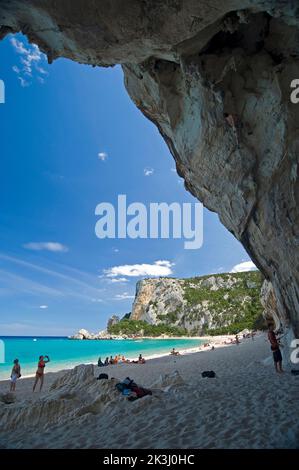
[0,0,299,335]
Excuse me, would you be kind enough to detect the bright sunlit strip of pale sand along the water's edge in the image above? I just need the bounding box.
[0,333,240,384]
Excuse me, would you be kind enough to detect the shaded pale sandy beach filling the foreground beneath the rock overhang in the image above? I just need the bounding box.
[0,334,299,448]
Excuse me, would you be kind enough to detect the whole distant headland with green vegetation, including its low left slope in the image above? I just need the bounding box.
[108,271,264,336]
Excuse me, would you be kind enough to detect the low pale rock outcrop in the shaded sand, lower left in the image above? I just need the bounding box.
[1,364,121,433]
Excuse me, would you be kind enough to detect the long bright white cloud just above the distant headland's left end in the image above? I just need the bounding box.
[104,260,174,278]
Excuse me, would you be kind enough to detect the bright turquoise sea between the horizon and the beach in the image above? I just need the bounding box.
[0,336,202,380]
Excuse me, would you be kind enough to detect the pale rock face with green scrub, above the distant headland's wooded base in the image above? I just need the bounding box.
[130,272,263,334]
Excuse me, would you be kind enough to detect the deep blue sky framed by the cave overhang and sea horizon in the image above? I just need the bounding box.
[0,35,255,335]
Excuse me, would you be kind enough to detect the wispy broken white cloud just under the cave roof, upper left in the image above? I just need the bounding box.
[10,37,48,87]
